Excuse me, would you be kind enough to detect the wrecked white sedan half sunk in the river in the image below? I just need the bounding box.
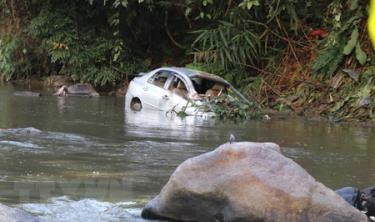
[125,67,247,115]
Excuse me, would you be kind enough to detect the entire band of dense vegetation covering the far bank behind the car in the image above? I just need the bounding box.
[0,0,375,120]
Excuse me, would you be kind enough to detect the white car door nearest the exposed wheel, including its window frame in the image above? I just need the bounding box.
[142,70,172,110]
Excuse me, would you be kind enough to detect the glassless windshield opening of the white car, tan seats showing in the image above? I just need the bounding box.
[190,76,227,96]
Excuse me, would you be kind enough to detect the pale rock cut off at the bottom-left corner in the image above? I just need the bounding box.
[0,204,39,222]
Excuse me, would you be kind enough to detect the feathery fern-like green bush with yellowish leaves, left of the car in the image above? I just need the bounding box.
[28,5,129,85]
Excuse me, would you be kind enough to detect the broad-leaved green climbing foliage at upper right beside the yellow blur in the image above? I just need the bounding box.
[313,0,367,76]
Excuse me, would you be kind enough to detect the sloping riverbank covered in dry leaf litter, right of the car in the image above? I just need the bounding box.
[255,69,375,123]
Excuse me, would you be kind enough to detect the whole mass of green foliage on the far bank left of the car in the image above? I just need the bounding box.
[0,0,148,86]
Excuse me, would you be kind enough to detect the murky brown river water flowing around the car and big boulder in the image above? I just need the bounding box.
[0,85,375,221]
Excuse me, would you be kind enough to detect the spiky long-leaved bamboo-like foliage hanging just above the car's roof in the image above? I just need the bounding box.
[188,0,329,87]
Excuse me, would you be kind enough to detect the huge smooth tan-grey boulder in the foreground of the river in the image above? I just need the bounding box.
[142,142,367,222]
